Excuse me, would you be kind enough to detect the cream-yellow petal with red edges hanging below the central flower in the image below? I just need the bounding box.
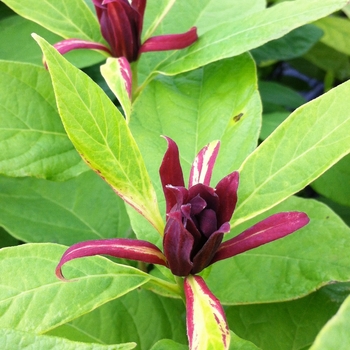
[184,275,230,350]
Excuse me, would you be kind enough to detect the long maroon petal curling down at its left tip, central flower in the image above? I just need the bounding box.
[56,238,167,280]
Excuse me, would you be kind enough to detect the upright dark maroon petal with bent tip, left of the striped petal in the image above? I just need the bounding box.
[159,136,185,213]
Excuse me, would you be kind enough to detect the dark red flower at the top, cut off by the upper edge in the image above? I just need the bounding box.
[54,0,198,62]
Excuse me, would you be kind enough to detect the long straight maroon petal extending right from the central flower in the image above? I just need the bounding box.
[211,212,310,263]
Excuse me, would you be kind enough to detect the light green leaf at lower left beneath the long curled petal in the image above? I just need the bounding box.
[0,243,149,333]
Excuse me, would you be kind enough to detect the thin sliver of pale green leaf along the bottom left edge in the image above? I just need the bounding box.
[0,329,136,350]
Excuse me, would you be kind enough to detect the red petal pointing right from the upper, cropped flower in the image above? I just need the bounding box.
[139,27,198,53]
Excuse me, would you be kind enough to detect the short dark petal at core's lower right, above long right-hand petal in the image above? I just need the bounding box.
[191,222,230,274]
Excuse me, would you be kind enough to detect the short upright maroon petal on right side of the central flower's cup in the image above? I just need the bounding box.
[215,171,239,226]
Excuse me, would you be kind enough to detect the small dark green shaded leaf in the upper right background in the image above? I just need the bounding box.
[251,24,323,64]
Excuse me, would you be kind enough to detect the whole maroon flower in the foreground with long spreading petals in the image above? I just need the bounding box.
[56,137,309,349]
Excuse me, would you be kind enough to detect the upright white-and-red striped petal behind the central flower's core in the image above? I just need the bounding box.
[188,141,220,188]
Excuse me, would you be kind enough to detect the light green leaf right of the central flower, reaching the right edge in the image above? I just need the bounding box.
[233,81,350,225]
